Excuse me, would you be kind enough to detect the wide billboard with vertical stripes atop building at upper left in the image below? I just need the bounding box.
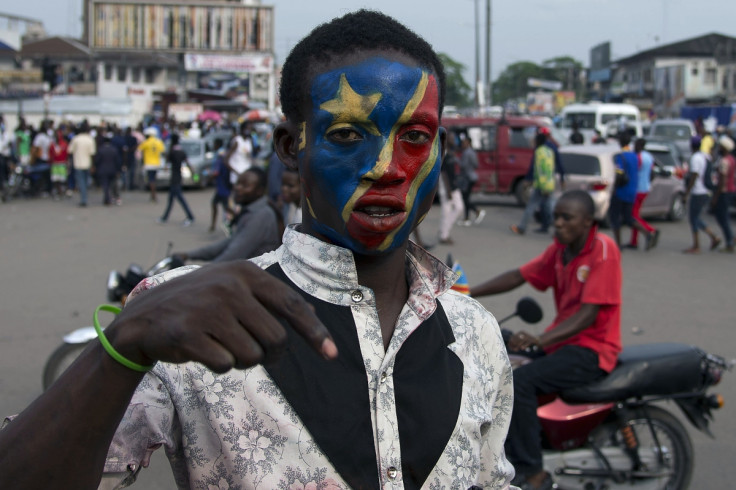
[86,0,273,52]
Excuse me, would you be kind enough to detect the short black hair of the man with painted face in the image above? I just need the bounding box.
[279,9,445,122]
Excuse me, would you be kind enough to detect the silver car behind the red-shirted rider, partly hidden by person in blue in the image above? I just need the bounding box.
[560,145,685,223]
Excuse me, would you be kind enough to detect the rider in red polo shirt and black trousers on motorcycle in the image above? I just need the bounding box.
[470,190,621,489]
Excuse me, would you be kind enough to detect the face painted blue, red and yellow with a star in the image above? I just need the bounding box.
[300,58,441,254]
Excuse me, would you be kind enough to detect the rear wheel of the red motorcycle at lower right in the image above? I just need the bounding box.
[593,405,694,490]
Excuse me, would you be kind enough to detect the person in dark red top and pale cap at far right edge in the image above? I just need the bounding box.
[710,135,736,253]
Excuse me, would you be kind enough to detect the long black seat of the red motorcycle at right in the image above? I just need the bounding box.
[560,343,705,403]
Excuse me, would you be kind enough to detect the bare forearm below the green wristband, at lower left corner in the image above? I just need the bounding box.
[0,338,143,489]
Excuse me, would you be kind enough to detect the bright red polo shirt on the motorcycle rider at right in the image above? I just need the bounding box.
[521,226,621,372]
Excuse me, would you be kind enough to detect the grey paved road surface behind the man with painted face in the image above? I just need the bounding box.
[0,190,736,490]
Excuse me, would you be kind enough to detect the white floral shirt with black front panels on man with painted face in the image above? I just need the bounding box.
[103,225,513,490]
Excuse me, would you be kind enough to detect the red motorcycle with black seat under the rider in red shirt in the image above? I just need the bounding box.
[499,298,735,490]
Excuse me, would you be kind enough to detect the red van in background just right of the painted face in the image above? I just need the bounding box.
[442,116,546,205]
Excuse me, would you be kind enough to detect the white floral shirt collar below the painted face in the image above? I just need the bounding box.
[276,224,457,317]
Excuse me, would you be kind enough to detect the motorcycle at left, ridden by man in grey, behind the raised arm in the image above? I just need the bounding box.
[43,249,184,390]
